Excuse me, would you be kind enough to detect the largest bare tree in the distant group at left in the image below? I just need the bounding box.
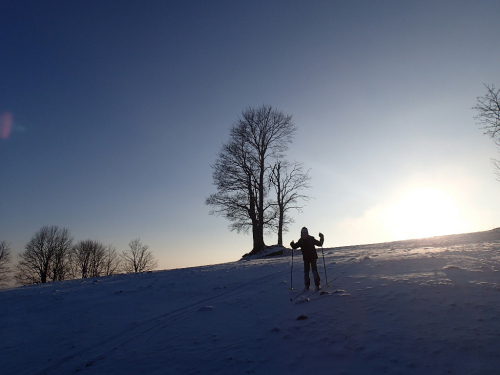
[15,226,73,285]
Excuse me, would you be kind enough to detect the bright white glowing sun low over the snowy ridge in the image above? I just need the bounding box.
[381,187,463,240]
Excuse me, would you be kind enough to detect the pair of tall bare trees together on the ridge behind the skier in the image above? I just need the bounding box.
[205,105,310,254]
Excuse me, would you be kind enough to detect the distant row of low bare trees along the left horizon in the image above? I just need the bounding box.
[0,226,158,286]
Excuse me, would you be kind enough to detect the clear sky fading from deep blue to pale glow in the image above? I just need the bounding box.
[0,0,500,269]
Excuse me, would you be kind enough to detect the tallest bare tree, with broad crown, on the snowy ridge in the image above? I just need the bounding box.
[205,105,296,254]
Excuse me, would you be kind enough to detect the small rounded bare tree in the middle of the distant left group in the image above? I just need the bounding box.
[70,240,106,279]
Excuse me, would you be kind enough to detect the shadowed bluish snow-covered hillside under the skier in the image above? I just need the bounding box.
[0,230,500,375]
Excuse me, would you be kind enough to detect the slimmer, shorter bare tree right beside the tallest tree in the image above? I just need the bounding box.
[269,160,311,245]
